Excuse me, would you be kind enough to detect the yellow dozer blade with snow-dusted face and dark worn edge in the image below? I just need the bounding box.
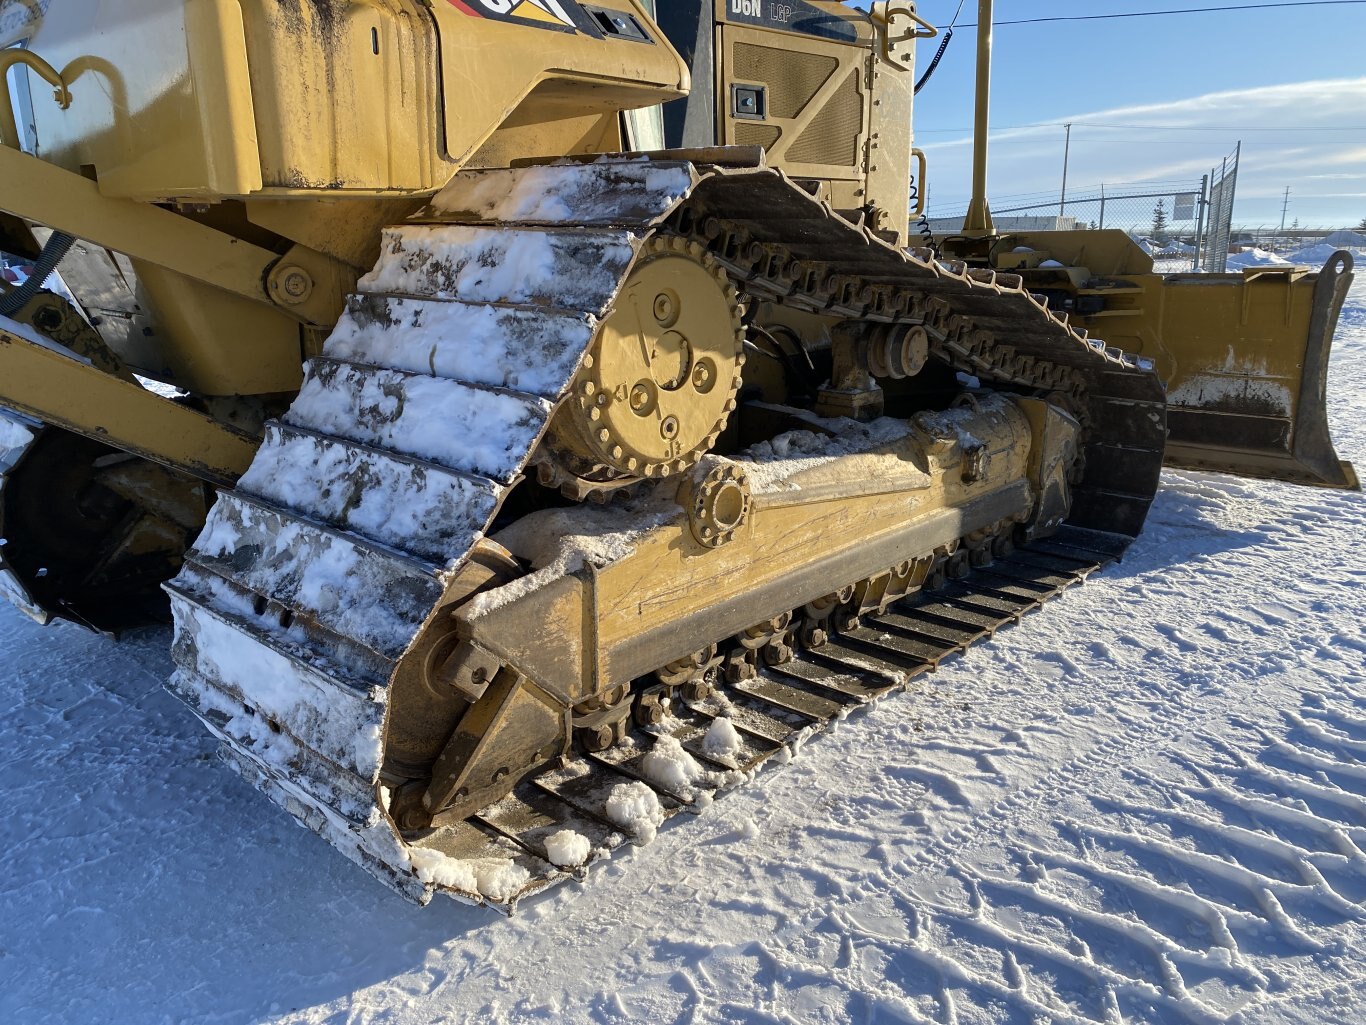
[1162,251,1361,491]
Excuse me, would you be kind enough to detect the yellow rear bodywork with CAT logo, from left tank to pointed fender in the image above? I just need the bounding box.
[15,0,688,202]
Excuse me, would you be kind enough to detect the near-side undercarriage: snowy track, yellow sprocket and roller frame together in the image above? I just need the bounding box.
[152,159,1164,905]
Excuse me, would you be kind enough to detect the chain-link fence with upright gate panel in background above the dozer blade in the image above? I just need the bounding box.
[930,150,1239,273]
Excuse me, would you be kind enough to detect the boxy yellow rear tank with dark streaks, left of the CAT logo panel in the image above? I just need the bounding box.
[13,0,451,201]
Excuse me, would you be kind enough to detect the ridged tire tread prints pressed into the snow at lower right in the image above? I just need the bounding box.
[680,666,1366,1024]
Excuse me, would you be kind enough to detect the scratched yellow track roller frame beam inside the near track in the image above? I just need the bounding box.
[458,403,1032,702]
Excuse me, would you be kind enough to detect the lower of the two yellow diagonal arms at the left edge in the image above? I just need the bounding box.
[0,321,257,487]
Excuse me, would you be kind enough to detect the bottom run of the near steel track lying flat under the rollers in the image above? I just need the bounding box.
[408,528,1128,914]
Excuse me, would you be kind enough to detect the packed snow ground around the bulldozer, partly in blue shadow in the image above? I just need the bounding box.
[0,284,1366,1025]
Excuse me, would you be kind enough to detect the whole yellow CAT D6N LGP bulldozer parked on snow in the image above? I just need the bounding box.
[0,0,1356,909]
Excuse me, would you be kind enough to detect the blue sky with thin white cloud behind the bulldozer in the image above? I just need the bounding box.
[858,0,1366,227]
